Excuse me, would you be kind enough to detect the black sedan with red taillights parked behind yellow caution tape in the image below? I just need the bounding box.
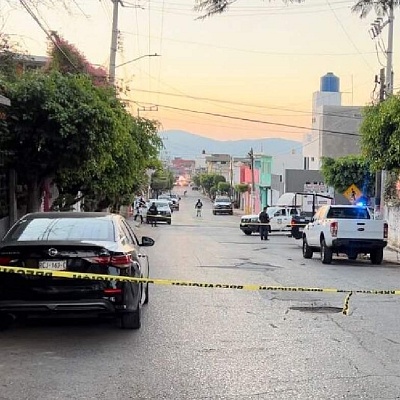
[0,212,154,329]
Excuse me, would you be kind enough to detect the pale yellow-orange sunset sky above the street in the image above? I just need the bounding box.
[0,0,400,147]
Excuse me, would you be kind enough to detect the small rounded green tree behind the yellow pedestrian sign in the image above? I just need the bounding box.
[321,155,375,197]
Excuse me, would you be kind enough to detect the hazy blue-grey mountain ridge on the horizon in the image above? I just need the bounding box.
[159,130,301,159]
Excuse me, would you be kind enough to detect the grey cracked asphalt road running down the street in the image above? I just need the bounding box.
[0,189,400,400]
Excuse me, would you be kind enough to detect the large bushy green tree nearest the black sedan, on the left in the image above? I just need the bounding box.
[3,71,134,211]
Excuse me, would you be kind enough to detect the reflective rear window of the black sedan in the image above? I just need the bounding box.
[3,218,114,242]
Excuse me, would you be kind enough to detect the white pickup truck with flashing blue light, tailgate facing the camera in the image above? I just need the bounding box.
[303,205,388,264]
